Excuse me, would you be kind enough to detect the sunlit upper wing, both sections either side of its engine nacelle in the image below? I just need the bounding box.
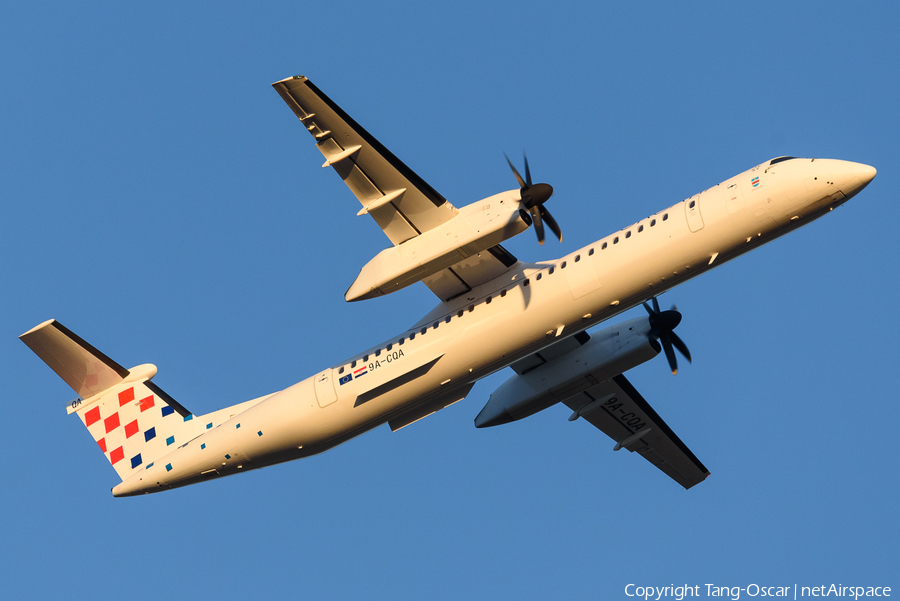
[272,75,517,300]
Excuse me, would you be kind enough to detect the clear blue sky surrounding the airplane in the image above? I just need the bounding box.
[0,2,900,599]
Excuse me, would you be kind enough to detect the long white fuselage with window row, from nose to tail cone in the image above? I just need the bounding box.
[113,159,875,496]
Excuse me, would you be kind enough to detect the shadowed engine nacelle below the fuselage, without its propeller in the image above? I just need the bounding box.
[475,317,660,428]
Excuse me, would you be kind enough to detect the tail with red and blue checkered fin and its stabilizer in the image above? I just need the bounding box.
[19,319,207,480]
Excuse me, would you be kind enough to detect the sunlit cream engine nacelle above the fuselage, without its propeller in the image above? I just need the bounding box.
[344,190,531,301]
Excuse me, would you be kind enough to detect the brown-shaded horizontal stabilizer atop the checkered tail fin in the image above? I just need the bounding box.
[19,319,129,399]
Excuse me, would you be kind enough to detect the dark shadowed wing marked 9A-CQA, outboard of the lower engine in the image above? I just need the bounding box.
[563,375,709,488]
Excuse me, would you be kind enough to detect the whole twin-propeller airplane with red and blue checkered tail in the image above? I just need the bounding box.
[20,76,876,497]
